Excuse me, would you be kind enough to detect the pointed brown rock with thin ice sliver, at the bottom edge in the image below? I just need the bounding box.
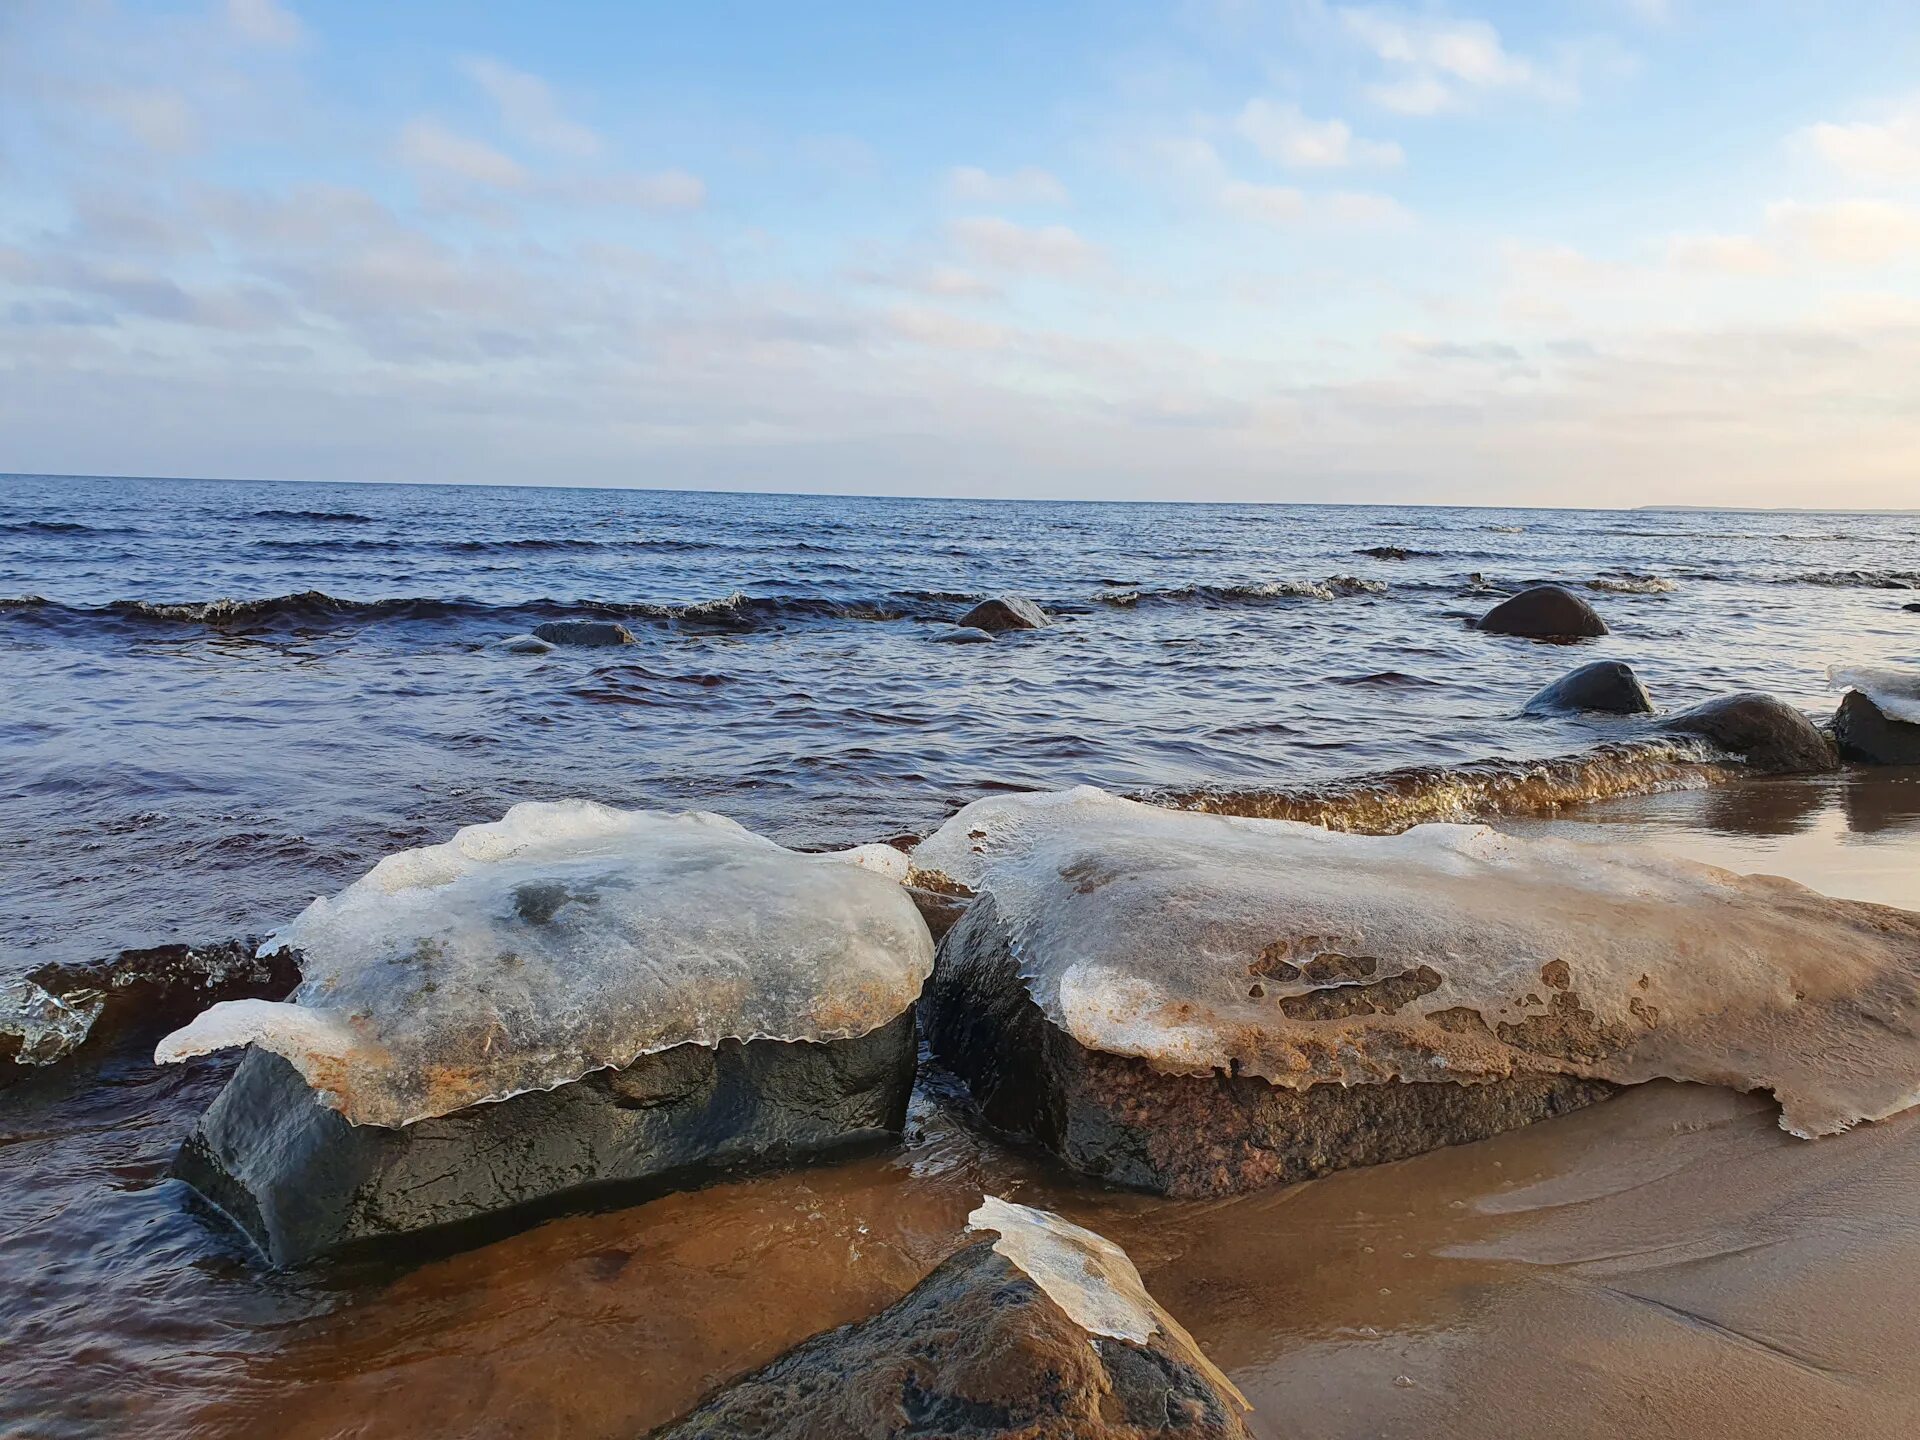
[655,1196,1246,1440]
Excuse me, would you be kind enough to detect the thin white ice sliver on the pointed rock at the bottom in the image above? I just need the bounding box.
[966,1194,1252,1409]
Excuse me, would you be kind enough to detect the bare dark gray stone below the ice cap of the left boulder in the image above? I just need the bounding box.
[173,1012,916,1265]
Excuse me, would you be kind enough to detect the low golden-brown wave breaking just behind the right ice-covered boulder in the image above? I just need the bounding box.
[1137,739,1743,835]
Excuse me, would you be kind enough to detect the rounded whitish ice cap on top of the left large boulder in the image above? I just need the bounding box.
[156,801,933,1127]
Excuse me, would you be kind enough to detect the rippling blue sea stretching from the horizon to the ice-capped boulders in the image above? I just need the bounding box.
[0,476,1920,973]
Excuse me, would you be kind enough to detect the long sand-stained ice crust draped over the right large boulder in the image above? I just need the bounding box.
[912,787,1920,1137]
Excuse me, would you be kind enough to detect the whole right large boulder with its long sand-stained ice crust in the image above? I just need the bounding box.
[914,787,1920,1194]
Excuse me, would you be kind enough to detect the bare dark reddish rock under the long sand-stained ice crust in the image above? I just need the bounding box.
[920,895,1613,1196]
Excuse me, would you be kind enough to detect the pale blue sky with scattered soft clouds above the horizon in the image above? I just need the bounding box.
[0,0,1920,507]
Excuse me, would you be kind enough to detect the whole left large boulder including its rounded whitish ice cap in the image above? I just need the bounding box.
[156,801,933,1263]
